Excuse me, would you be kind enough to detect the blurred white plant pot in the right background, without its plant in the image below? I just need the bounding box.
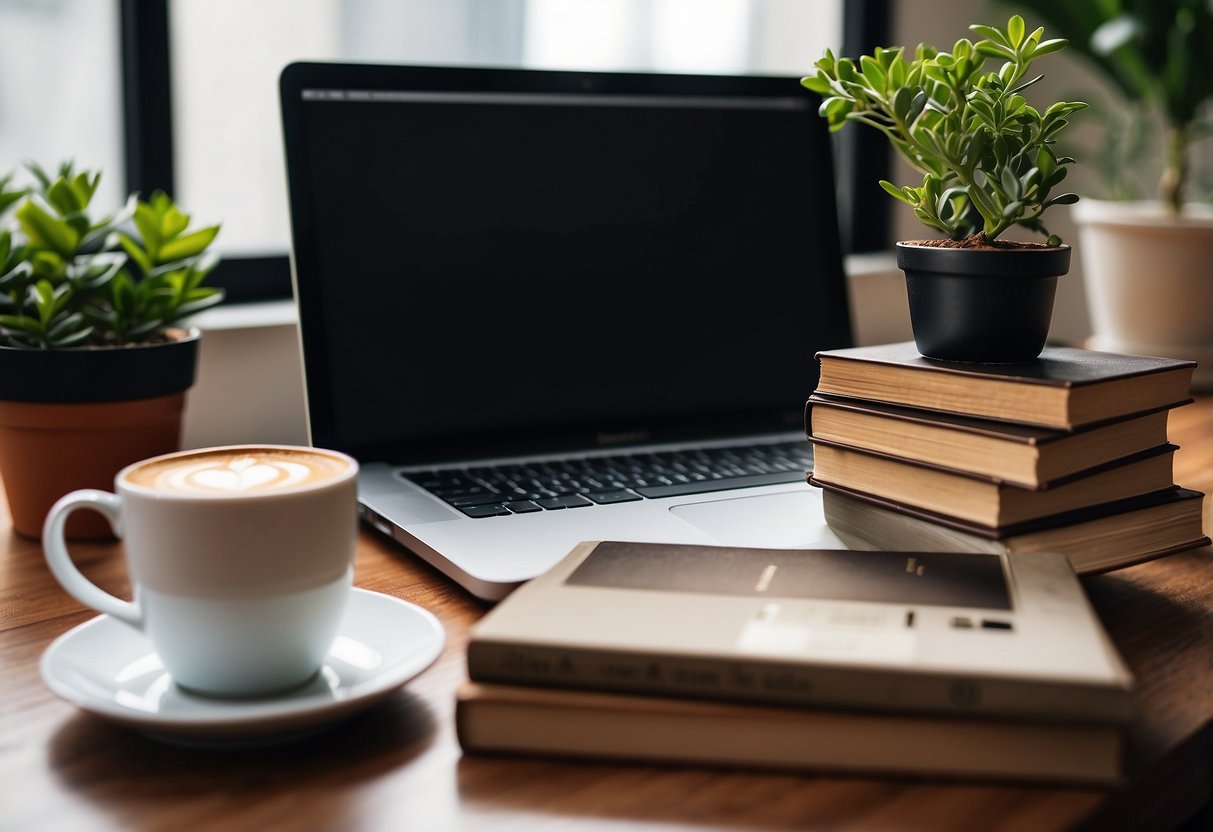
[1072,199,1213,391]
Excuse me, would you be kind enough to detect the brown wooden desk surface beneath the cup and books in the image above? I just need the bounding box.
[0,397,1213,832]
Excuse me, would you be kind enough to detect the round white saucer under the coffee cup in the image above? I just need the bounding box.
[41,589,446,745]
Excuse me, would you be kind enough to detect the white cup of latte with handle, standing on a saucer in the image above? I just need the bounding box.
[42,445,358,696]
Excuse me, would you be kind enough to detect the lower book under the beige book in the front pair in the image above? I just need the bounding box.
[455,682,1123,786]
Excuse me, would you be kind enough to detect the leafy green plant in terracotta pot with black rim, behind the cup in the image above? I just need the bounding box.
[0,163,223,537]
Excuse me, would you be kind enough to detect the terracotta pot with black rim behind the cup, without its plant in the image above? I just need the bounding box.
[0,330,200,538]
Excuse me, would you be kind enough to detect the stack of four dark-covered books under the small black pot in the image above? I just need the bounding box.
[805,342,1208,574]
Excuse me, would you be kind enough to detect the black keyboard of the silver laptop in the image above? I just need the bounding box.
[404,440,811,517]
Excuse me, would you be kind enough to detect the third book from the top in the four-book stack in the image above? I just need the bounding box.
[809,438,1177,529]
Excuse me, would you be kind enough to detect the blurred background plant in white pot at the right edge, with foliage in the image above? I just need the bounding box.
[1004,0,1213,389]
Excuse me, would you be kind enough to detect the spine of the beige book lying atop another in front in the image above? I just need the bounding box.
[467,639,1132,722]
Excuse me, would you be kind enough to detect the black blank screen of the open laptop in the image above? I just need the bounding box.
[281,64,849,461]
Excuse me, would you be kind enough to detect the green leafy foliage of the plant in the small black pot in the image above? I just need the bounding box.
[802,15,1086,245]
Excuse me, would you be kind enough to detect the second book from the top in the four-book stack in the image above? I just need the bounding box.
[804,393,1174,489]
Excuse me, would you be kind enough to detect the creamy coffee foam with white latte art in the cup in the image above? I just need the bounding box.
[126,448,349,496]
